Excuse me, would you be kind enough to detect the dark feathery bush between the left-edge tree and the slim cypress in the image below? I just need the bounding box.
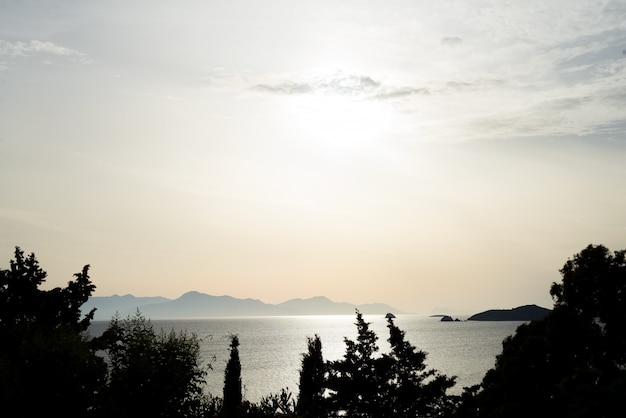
[98,311,210,417]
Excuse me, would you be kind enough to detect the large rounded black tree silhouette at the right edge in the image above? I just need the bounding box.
[476,245,626,417]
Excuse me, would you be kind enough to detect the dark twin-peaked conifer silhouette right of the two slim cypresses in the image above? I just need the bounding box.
[326,310,455,417]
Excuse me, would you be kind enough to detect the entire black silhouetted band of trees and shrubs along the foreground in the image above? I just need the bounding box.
[0,245,626,418]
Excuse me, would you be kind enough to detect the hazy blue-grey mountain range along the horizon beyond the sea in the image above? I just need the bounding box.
[81,291,402,320]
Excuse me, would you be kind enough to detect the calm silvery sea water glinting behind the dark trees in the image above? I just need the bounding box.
[85,315,522,402]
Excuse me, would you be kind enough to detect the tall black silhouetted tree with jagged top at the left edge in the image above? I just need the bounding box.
[0,247,106,417]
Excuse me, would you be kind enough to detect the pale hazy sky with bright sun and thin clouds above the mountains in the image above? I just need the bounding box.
[0,0,626,313]
